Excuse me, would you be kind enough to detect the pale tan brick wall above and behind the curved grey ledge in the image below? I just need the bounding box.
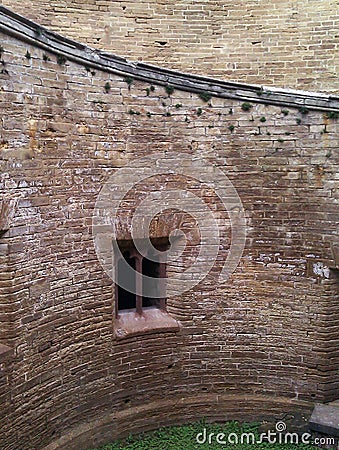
[0,0,339,92]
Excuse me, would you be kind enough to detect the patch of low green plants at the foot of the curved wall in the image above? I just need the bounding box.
[91,421,318,450]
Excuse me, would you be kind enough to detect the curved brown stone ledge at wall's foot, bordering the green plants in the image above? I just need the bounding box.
[44,394,314,450]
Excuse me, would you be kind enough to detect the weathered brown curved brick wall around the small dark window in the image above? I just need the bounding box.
[0,7,339,450]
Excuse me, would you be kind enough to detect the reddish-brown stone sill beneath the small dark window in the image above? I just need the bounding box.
[114,308,179,339]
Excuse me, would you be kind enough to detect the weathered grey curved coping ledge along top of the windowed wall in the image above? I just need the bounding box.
[0,6,339,112]
